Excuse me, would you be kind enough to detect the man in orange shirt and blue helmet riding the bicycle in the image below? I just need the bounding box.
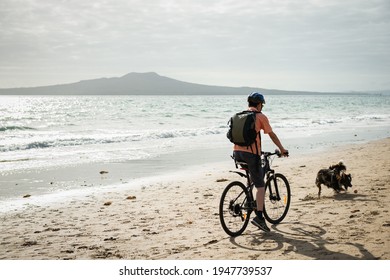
[233,92,288,232]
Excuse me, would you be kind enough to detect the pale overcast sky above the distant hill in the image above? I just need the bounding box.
[0,0,390,91]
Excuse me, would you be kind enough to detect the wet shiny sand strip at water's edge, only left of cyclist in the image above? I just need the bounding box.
[0,145,230,209]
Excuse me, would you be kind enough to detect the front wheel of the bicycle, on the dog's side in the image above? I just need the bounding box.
[263,173,291,224]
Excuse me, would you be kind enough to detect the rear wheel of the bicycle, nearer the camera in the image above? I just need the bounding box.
[219,181,252,237]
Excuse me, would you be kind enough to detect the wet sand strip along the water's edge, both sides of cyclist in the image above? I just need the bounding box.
[0,124,390,206]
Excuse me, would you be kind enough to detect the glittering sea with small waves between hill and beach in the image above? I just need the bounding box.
[0,94,390,205]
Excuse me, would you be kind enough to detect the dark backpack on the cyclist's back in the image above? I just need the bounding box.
[226,111,259,147]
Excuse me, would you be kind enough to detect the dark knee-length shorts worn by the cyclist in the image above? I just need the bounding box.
[233,151,265,188]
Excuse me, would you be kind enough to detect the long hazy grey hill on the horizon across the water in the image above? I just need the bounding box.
[0,72,358,95]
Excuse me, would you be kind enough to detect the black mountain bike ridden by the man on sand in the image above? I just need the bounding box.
[219,150,291,237]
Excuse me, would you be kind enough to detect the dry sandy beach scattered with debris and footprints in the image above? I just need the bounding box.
[0,138,390,260]
